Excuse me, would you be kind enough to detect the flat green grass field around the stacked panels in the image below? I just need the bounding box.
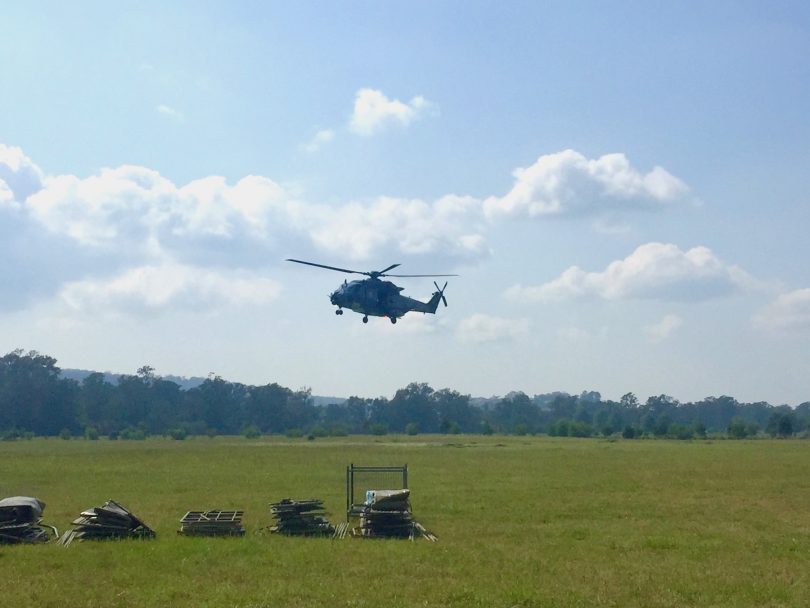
[0,436,810,607]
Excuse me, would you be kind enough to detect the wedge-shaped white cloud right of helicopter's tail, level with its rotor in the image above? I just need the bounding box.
[506,243,753,302]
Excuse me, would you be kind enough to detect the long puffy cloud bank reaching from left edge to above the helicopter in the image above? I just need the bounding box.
[0,142,696,316]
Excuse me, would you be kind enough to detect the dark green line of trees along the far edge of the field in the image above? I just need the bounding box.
[0,350,810,439]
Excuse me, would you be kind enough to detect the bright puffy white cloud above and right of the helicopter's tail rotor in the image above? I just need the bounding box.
[484,150,689,217]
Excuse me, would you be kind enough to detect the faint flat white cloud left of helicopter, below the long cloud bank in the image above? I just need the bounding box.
[60,263,281,314]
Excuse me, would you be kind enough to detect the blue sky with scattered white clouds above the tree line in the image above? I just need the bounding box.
[0,1,810,405]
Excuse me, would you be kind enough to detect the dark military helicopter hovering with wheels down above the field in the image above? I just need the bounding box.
[286,258,458,323]
